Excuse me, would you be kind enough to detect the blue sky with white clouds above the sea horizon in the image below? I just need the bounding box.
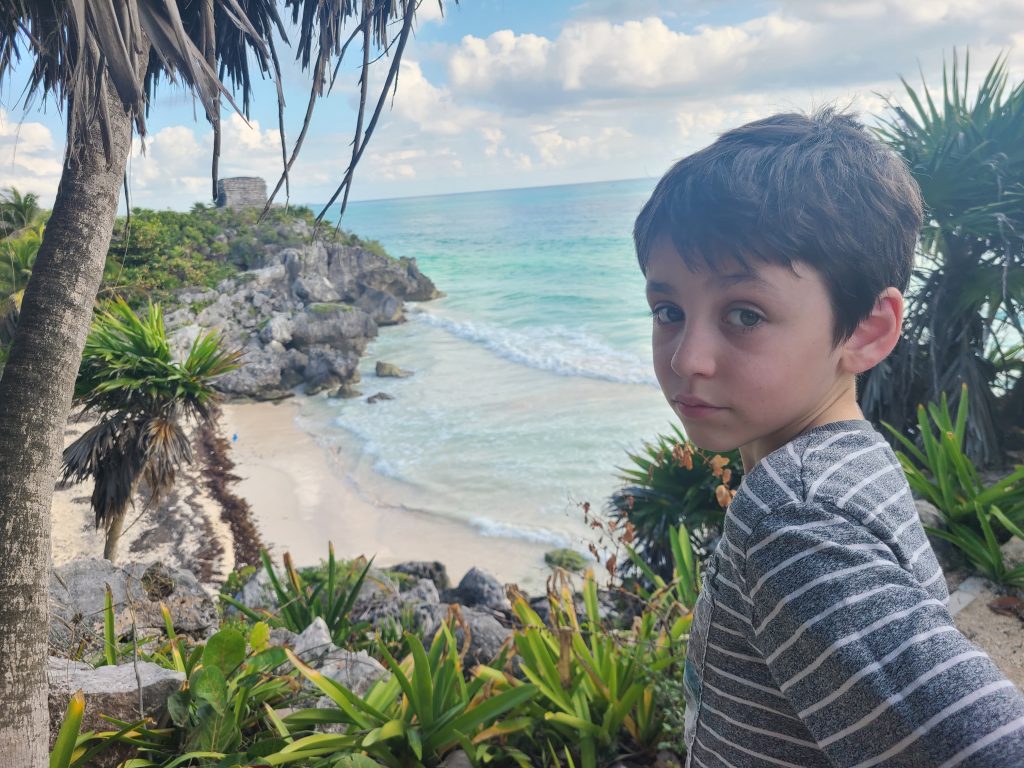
[0,0,1024,210]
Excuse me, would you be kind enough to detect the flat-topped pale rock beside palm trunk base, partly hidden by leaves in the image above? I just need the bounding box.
[46,656,185,766]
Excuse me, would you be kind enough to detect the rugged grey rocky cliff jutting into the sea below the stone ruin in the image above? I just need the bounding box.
[166,215,442,399]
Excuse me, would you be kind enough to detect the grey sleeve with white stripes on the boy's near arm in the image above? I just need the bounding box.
[744,504,1024,768]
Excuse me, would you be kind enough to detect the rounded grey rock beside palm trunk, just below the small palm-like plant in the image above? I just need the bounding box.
[49,558,217,653]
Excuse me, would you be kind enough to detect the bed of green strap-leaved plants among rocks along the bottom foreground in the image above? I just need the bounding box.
[53,530,695,768]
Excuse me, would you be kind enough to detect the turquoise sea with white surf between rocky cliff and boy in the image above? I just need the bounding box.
[303,180,673,548]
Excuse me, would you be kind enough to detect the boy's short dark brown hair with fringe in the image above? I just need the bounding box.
[633,109,923,344]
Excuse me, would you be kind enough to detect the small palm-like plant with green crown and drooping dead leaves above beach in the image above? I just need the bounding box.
[62,298,241,561]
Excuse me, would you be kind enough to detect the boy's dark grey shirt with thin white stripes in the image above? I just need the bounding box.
[684,421,1024,768]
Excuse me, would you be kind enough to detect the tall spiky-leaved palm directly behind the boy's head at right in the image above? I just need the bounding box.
[861,52,1024,465]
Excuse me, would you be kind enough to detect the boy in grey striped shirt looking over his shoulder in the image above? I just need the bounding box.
[634,110,1024,768]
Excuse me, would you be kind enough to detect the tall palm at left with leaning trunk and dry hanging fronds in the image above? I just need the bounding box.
[0,0,436,757]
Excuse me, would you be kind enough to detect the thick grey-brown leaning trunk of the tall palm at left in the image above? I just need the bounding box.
[0,81,132,768]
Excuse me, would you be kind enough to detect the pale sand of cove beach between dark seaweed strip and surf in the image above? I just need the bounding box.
[221,400,561,594]
